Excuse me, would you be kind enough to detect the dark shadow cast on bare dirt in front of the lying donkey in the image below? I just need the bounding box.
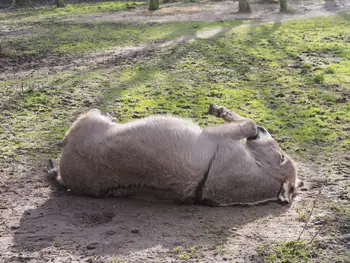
[13,180,288,256]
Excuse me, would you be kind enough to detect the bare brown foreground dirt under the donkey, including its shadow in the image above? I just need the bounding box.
[0,160,349,262]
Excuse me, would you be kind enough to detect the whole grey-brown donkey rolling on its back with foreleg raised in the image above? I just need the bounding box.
[48,104,297,206]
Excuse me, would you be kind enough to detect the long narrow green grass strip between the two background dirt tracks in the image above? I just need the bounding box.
[2,21,242,56]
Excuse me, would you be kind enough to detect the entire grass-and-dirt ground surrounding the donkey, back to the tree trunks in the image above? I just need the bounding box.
[0,1,350,263]
